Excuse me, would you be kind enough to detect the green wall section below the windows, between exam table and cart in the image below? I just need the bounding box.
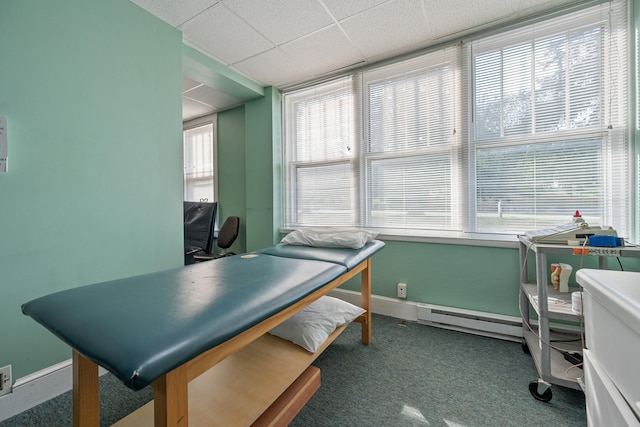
[338,241,519,316]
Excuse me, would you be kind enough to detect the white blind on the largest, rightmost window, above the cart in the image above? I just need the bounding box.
[468,2,631,236]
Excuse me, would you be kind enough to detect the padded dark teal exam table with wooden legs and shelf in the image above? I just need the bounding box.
[22,240,384,427]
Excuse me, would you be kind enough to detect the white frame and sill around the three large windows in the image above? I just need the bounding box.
[283,1,637,247]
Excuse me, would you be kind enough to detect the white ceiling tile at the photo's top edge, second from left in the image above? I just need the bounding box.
[224,0,334,45]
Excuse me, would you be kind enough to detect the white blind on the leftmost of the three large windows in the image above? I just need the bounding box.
[284,77,358,227]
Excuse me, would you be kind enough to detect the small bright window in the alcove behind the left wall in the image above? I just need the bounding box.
[183,123,216,202]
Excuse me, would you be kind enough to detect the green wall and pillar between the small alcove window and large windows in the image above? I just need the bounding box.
[217,87,282,253]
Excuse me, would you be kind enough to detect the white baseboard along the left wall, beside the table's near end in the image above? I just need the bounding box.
[0,359,107,422]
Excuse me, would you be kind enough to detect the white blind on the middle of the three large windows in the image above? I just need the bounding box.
[360,47,461,230]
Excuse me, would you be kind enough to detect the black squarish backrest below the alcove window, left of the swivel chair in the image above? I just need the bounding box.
[184,202,218,253]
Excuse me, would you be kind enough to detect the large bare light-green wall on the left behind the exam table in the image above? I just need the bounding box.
[0,0,183,378]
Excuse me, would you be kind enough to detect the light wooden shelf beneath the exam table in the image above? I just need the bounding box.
[114,326,346,427]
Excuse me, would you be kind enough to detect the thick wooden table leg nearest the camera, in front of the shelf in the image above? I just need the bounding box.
[151,364,189,427]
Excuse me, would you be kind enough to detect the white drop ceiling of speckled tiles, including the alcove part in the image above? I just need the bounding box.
[131,0,584,117]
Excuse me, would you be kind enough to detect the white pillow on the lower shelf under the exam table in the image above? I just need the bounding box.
[269,296,366,353]
